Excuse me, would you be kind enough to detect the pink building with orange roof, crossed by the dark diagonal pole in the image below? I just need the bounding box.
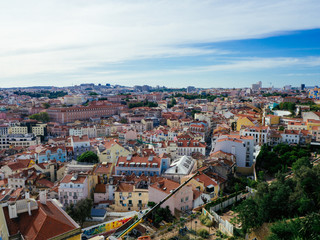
[149,179,193,214]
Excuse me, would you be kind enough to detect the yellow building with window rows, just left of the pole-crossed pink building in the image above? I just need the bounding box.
[111,181,149,212]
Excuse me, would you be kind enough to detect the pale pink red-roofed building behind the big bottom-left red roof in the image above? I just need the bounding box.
[58,174,88,207]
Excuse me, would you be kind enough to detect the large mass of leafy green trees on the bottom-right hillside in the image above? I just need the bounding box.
[236,165,320,232]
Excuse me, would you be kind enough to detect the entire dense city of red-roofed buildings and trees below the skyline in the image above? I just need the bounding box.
[0,82,320,239]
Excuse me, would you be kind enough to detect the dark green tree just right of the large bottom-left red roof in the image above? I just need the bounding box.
[66,198,93,228]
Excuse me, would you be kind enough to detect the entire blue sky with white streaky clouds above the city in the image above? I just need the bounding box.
[0,0,320,88]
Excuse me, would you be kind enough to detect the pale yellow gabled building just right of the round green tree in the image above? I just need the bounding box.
[97,139,130,163]
